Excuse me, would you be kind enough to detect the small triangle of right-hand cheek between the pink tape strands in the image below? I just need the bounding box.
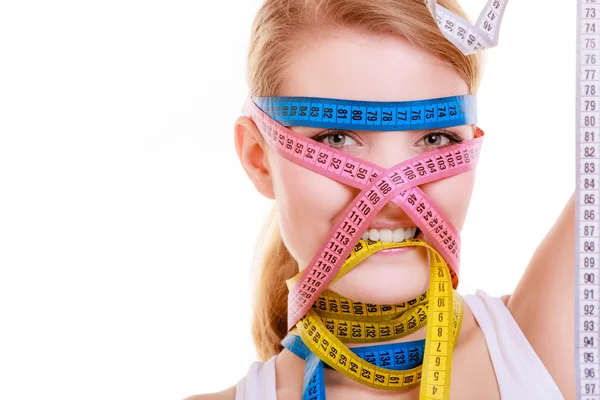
[420,171,475,232]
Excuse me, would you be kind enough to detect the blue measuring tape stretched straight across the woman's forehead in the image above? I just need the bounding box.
[252,95,477,131]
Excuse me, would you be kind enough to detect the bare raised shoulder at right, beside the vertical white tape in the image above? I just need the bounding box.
[507,194,577,399]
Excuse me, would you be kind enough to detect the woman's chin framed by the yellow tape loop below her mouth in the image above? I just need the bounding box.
[329,256,429,304]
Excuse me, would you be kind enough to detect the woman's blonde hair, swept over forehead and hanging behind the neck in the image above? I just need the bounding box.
[248,0,482,361]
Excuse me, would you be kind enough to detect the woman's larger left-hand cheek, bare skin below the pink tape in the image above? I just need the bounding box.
[271,157,358,269]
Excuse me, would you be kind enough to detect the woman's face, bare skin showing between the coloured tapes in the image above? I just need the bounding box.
[265,28,475,304]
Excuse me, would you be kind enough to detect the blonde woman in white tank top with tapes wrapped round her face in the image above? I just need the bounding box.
[189,0,575,400]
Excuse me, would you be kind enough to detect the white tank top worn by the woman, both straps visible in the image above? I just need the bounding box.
[235,290,564,400]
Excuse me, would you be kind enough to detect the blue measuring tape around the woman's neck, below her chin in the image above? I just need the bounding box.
[281,334,425,400]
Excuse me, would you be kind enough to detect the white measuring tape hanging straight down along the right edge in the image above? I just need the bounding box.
[575,0,600,400]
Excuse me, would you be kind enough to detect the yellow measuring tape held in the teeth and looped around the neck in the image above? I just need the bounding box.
[286,239,463,400]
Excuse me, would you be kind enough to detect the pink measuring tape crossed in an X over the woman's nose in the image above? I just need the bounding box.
[243,97,484,330]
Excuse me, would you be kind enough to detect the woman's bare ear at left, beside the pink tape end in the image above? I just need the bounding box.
[233,117,275,200]
